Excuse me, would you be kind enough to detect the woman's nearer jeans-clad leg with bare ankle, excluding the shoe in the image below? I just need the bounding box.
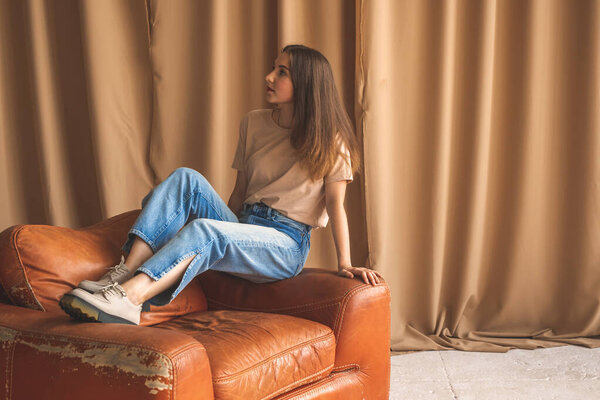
[122,218,310,305]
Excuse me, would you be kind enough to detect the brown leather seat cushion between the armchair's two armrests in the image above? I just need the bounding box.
[155,310,335,399]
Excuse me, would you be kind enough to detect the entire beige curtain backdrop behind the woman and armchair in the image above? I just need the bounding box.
[0,0,600,351]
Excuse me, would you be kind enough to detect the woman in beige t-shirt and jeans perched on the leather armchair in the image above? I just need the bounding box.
[60,45,381,324]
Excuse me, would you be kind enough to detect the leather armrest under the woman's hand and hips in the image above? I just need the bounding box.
[197,268,390,399]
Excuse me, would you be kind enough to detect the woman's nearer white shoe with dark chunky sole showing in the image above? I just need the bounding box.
[59,282,142,325]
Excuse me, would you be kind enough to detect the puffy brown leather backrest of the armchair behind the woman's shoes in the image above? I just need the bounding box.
[0,210,206,325]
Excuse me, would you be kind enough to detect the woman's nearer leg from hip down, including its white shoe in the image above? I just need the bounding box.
[61,218,310,324]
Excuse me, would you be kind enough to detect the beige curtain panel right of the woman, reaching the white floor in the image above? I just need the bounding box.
[360,1,600,351]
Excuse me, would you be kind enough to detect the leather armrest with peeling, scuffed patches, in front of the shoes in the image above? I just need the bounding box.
[0,304,213,400]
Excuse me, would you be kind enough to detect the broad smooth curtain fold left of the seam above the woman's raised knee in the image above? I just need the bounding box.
[74,0,155,217]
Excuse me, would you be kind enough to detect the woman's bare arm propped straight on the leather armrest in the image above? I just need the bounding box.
[325,181,381,285]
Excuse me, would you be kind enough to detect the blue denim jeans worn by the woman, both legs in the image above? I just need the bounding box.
[121,168,312,305]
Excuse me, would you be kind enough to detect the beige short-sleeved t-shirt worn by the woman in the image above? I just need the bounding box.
[231,109,353,228]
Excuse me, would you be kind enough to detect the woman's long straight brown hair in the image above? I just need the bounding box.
[282,44,360,181]
